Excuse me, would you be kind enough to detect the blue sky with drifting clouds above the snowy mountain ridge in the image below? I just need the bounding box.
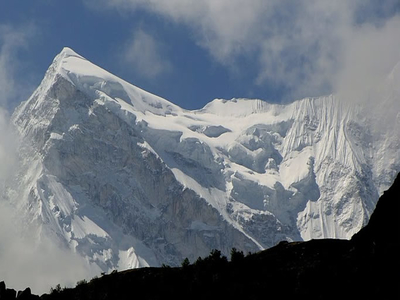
[0,0,400,110]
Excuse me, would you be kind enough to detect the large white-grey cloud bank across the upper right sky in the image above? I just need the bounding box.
[86,0,400,102]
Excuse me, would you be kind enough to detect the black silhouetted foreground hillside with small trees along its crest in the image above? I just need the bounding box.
[0,175,400,300]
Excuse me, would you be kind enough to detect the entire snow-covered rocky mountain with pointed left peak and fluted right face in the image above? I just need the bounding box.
[5,48,400,271]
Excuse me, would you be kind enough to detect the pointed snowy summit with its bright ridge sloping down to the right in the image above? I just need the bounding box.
[32,47,181,115]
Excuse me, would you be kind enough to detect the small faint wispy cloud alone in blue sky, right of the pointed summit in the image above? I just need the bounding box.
[123,29,171,79]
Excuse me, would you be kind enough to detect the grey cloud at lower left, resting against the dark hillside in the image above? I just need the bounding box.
[0,202,98,294]
